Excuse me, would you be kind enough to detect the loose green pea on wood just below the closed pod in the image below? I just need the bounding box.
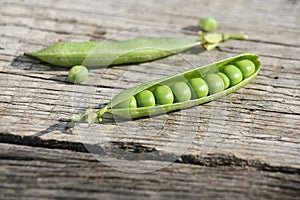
[68,65,89,83]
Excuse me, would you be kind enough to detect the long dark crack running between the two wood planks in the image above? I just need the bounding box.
[0,133,300,174]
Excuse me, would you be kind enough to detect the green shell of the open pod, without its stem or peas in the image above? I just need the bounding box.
[106,53,261,119]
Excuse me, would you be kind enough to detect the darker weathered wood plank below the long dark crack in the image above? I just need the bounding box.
[0,144,300,199]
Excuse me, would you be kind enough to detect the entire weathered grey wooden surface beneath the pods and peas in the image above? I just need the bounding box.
[0,0,300,199]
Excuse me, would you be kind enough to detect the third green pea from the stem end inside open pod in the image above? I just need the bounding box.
[153,85,174,105]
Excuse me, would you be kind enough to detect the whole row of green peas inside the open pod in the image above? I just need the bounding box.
[114,59,256,109]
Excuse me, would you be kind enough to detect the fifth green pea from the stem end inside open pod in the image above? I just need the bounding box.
[189,78,208,99]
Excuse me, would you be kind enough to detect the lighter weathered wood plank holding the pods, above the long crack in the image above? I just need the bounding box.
[0,0,300,170]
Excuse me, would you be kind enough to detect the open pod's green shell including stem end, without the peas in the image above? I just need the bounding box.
[73,53,261,121]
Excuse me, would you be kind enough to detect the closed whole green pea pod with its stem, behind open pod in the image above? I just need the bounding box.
[25,33,247,67]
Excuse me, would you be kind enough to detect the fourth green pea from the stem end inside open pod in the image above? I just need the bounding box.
[171,82,192,102]
